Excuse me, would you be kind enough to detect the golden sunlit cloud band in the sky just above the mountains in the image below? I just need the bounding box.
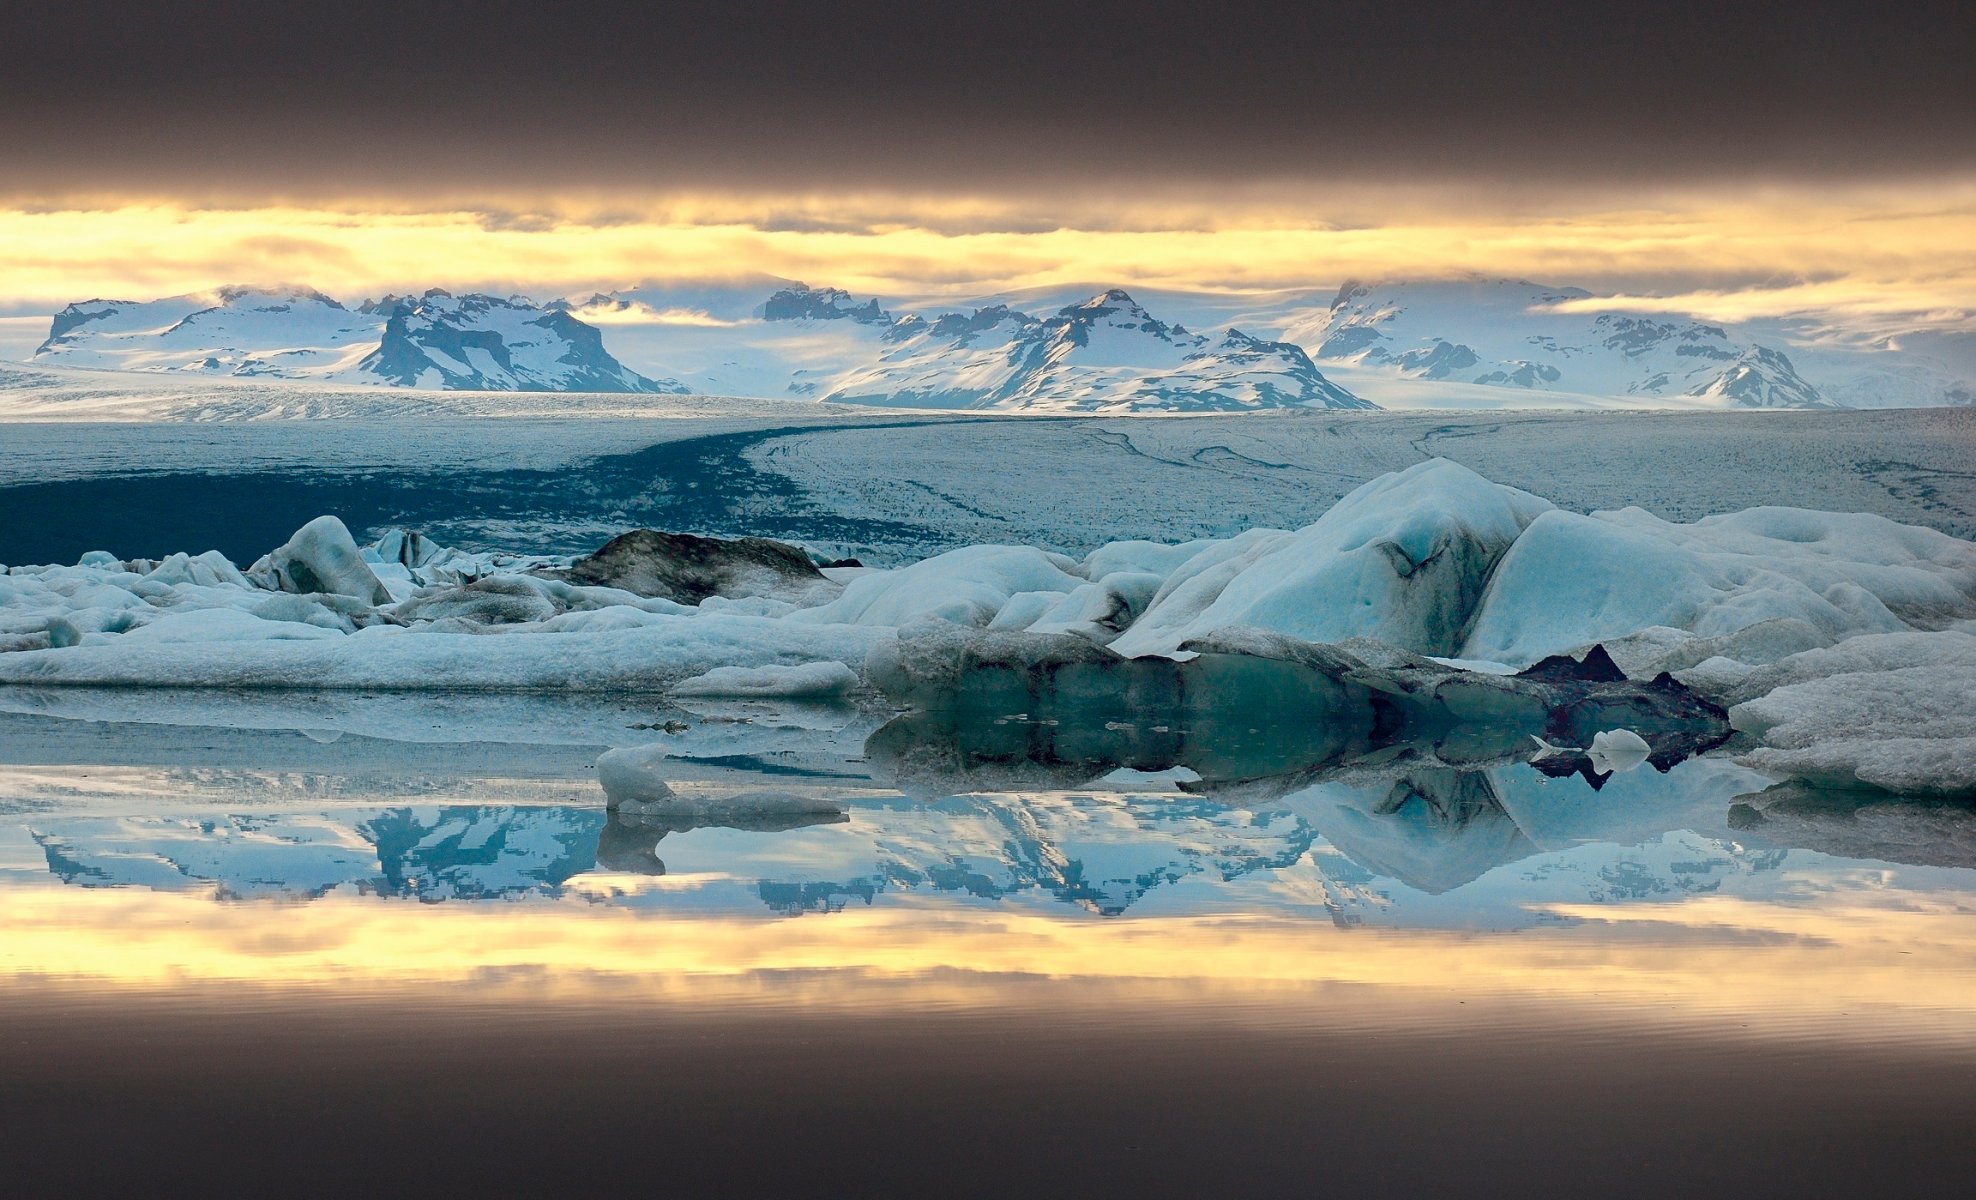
[0,180,1976,328]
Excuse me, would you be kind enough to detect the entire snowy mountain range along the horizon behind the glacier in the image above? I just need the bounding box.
[19,275,1976,413]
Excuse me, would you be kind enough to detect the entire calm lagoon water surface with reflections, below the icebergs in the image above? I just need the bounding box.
[0,692,1976,1196]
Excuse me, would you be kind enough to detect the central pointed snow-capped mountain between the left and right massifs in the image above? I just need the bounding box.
[826,289,1373,411]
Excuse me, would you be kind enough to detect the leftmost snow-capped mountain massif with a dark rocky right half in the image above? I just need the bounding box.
[34,287,684,391]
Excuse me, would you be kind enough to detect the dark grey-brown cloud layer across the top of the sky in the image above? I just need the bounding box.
[0,0,1976,196]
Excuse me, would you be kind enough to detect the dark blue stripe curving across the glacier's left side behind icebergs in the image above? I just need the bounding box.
[0,421,939,563]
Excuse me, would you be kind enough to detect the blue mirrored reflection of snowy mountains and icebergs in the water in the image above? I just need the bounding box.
[11,699,1976,925]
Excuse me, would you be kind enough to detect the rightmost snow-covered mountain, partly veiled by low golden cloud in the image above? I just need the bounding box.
[1284,279,1834,407]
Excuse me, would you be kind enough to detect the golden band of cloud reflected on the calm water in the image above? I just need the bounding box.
[0,876,1976,1046]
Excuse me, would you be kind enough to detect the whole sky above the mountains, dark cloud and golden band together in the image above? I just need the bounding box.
[0,0,1976,328]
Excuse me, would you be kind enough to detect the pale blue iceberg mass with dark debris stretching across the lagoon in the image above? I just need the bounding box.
[0,459,1976,795]
